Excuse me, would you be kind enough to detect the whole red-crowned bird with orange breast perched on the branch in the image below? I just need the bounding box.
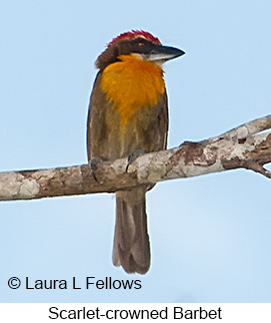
[87,30,184,274]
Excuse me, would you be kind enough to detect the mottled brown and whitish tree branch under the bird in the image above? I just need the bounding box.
[0,115,271,200]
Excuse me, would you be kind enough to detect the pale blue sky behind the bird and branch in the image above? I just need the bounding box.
[0,0,271,302]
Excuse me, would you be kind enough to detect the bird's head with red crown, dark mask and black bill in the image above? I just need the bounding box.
[95,30,184,69]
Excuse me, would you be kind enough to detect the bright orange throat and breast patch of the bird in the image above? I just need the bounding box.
[101,55,165,124]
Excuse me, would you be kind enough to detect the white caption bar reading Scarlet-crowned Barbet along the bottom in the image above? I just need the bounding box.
[0,303,271,323]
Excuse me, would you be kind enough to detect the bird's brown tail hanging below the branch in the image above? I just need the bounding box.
[113,187,150,274]
